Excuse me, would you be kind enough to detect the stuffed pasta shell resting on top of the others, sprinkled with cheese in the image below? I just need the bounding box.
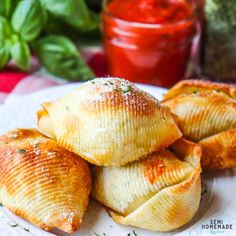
[38,78,182,166]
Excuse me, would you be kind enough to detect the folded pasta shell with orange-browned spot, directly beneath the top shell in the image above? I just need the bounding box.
[92,139,201,231]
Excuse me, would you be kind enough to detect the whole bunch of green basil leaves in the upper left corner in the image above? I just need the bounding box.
[0,0,98,80]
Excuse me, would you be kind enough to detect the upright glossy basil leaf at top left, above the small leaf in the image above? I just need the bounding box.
[11,0,46,41]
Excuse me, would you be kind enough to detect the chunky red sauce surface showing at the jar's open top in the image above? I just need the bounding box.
[107,0,192,24]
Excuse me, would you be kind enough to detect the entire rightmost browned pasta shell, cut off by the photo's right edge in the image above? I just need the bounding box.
[162,80,236,169]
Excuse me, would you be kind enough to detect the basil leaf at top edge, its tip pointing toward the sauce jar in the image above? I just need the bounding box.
[40,0,97,31]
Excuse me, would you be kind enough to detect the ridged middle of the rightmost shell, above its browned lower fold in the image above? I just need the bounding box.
[163,92,236,142]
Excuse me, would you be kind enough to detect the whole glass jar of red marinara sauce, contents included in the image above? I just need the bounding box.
[101,0,195,87]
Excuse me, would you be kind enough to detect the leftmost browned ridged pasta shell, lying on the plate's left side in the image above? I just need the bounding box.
[0,129,91,233]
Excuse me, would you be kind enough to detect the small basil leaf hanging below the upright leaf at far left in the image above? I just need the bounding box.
[10,39,30,71]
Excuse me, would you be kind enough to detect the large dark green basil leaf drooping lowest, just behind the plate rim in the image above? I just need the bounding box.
[33,35,94,80]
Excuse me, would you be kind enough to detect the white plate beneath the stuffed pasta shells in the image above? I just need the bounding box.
[0,83,236,236]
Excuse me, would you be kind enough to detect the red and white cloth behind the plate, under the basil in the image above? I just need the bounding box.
[0,47,107,103]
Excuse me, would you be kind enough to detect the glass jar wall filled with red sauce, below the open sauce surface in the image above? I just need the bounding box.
[101,1,195,87]
